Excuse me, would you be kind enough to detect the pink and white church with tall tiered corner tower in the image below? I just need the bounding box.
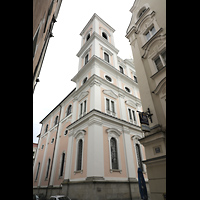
[33,14,149,200]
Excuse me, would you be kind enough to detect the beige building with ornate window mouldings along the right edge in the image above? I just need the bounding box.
[126,0,166,200]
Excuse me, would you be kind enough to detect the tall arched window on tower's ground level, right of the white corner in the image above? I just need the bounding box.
[110,138,119,169]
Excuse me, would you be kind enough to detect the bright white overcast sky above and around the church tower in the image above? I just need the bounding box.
[33,0,135,143]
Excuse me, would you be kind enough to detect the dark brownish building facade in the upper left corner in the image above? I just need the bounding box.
[33,0,62,92]
